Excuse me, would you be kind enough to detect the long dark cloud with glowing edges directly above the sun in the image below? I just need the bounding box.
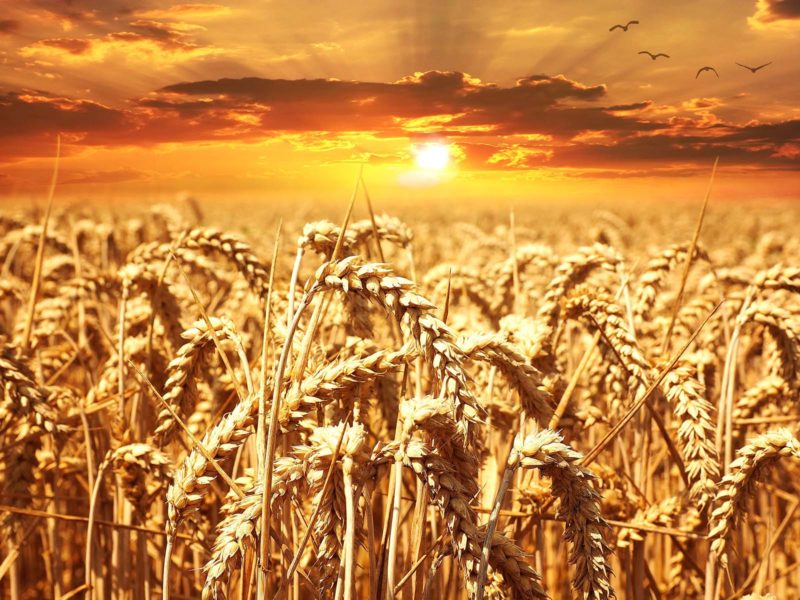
[153,71,620,135]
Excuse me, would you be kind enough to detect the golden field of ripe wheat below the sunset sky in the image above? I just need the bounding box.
[0,193,800,600]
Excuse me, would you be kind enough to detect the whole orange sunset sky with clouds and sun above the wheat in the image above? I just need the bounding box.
[0,0,800,200]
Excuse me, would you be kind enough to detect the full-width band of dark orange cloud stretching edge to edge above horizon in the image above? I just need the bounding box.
[0,71,800,177]
